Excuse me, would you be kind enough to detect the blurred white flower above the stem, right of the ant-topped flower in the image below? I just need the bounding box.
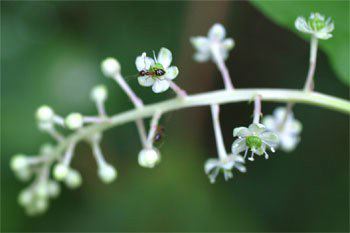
[190,23,235,62]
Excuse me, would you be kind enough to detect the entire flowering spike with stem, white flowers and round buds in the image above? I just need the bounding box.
[11,13,350,215]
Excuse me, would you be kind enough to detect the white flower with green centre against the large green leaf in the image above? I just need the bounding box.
[295,13,334,40]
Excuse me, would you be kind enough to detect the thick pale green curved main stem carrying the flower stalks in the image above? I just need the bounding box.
[56,88,350,155]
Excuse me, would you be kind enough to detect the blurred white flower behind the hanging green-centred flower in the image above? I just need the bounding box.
[262,107,302,151]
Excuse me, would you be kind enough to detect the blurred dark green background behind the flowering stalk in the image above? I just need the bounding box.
[0,1,349,232]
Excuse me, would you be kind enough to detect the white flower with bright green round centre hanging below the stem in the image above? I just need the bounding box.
[232,123,278,161]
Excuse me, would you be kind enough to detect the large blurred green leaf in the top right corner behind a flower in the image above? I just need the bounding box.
[252,0,350,85]
